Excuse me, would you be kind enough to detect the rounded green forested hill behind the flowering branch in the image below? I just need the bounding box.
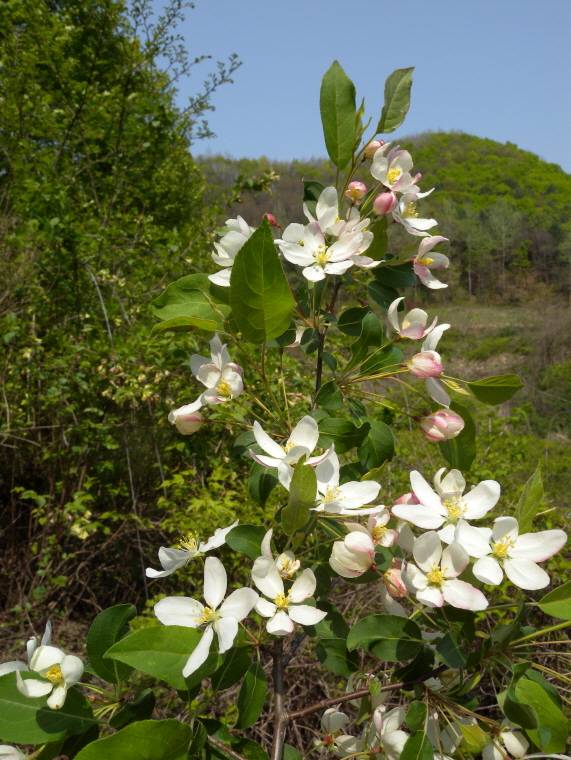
[204,132,571,300]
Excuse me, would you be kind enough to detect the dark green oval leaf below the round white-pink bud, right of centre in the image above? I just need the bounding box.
[347,615,423,662]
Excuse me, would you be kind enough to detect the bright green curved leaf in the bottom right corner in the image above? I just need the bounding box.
[515,678,569,752]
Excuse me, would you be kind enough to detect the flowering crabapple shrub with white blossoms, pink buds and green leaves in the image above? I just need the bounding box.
[0,62,571,760]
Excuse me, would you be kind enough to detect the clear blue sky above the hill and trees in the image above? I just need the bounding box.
[169,0,571,171]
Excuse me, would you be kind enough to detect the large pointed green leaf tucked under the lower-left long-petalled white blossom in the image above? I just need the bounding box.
[105,625,202,691]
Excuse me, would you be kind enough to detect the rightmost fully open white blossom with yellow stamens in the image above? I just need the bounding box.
[464,517,567,591]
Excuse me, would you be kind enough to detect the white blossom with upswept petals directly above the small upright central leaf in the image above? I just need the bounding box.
[249,414,327,478]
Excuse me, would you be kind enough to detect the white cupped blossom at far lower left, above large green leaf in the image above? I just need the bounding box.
[16,644,83,710]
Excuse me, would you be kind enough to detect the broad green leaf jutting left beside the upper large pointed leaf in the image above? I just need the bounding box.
[152,274,230,332]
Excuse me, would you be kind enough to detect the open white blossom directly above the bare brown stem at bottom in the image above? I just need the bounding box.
[252,556,327,636]
